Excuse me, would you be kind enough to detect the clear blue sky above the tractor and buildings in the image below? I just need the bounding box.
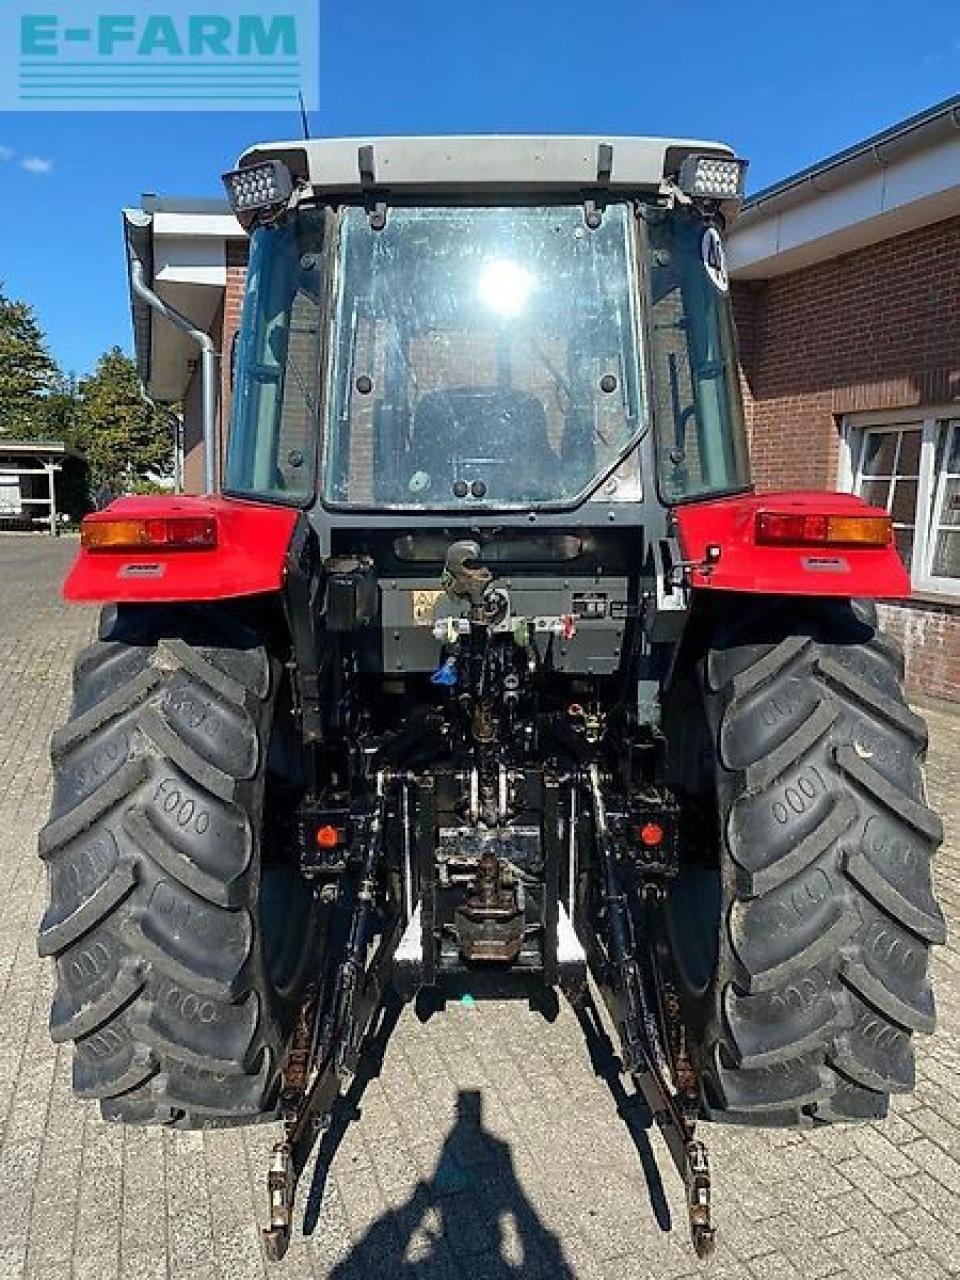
[0,0,960,374]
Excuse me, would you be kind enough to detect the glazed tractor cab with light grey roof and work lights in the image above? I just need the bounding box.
[224,137,749,525]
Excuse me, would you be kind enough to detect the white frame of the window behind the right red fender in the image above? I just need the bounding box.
[837,404,960,596]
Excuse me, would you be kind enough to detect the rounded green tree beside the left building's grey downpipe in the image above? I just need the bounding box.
[73,347,173,493]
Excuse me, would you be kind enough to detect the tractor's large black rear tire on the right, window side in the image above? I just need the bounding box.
[666,599,945,1124]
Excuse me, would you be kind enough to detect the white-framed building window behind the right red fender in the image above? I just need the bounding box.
[840,415,960,595]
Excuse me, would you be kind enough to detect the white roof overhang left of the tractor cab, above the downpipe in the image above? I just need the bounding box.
[123,197,246,404]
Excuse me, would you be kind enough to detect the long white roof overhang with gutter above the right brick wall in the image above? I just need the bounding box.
[727,97,960,279]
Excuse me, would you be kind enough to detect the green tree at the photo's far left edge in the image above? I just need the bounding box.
[0,284,59,439]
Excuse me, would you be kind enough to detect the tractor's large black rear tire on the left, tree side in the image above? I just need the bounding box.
[40,608,314,1128]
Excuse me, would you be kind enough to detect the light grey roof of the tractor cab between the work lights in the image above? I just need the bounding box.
[239,134,733,195]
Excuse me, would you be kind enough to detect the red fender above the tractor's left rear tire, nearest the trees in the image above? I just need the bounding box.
[63,495,300,604]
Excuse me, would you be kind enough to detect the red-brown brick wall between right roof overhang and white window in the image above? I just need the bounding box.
[733,216,960,489]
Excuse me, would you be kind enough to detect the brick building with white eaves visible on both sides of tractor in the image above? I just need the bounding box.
[125,97,960,700]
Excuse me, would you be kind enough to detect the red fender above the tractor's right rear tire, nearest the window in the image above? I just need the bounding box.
[673,490,910,599]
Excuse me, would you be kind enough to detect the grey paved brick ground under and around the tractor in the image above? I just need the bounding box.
[0,535,960,1280]
